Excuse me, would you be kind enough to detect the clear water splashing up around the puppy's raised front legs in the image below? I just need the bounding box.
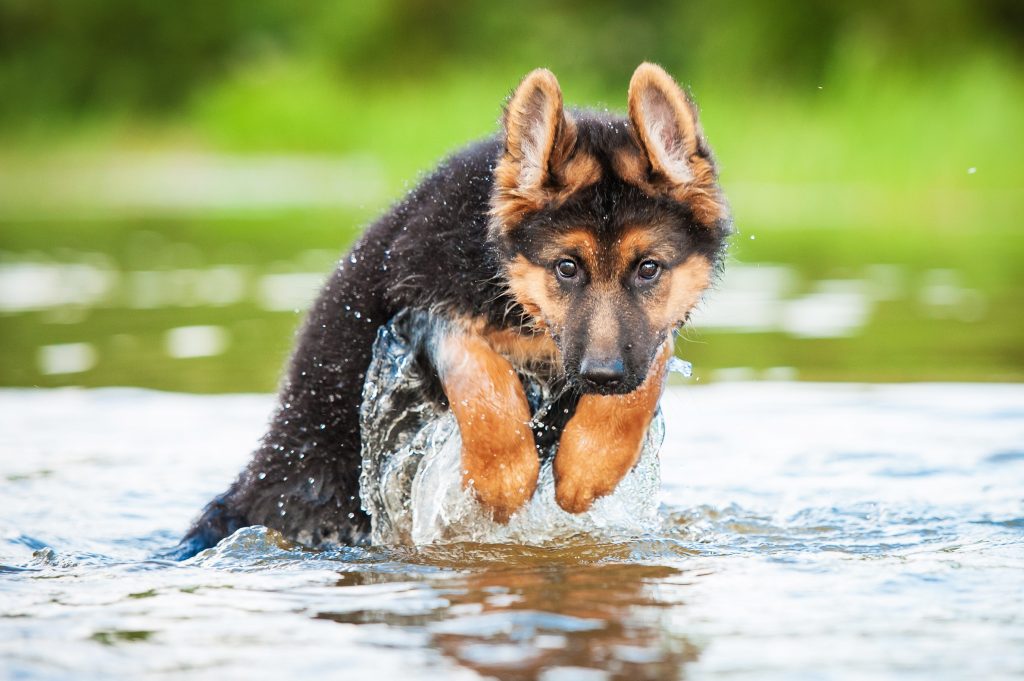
[359,315,663,545]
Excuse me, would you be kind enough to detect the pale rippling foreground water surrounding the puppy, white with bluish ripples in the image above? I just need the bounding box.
[0,383,1024,680]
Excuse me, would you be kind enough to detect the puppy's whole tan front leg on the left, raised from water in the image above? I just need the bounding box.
[435,329,540,522]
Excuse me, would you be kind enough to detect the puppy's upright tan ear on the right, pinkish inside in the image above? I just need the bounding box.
[629,62,710,185]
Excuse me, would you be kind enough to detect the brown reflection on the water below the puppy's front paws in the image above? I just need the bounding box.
[317,547,699,681]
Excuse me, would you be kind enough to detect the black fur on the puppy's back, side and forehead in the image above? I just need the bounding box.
[178,113,725,557]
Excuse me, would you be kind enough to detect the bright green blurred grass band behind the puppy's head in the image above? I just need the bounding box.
[0,53,1024,220]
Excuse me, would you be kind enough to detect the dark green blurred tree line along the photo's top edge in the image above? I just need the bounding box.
[0,0,1024,123]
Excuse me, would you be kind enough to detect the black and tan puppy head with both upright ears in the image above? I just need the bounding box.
[489,63,729,393]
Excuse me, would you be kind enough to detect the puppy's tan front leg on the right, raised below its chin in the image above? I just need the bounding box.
[554,339,673,513]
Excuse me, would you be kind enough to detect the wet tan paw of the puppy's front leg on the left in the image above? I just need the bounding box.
[463,445,541,524]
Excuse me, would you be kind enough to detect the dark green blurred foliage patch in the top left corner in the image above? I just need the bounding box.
[0,0,296,115]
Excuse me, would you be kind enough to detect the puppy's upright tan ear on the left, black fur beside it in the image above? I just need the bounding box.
[499,69,575,196]
